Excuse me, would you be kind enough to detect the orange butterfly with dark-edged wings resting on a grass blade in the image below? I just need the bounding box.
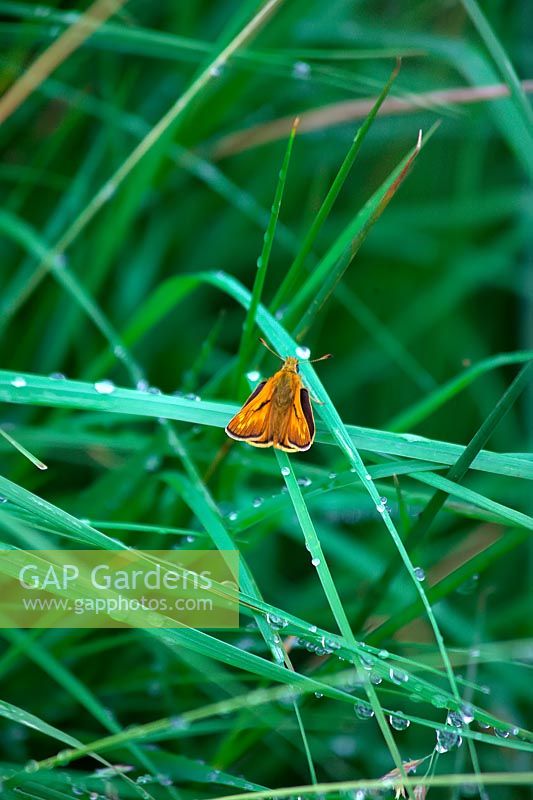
[226,339,331,453]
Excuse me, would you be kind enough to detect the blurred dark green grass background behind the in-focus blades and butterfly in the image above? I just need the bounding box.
[0,0,533,800]
